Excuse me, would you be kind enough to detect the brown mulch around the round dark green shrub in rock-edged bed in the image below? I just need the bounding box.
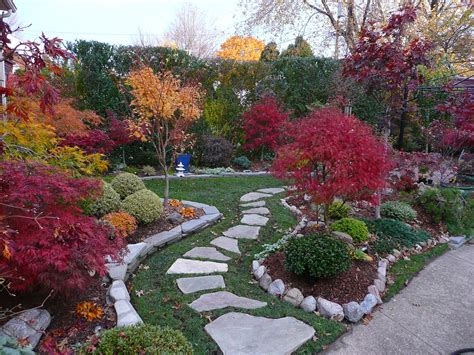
[264,252,377,304]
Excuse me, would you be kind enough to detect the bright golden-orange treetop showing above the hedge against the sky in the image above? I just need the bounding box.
[216,36,265,61]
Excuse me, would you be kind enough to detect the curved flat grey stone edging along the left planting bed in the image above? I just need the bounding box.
[106,200,222,327]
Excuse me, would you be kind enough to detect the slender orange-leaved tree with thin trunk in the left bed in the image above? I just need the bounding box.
[126,66,201,203]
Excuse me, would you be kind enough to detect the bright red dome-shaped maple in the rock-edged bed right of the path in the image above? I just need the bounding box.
[272,109,390,221]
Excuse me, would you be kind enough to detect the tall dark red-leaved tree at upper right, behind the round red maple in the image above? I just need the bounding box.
[343,5,430,148]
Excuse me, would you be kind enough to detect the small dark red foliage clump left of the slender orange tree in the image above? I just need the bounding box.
[61,129,116,154]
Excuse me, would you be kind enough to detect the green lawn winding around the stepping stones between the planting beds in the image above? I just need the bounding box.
[130,177,345,354]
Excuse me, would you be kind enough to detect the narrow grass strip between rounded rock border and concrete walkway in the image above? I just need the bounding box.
[383,244,448,302]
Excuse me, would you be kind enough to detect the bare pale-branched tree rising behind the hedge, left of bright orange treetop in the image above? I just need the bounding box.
[165,3,217,58]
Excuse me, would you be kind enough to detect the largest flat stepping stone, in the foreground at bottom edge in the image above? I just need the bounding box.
[204,312,315,355]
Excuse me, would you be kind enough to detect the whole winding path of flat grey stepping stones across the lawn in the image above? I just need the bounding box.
[165,188,315,354]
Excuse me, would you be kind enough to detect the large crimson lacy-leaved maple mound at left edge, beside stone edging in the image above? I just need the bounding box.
[0,162,123,294]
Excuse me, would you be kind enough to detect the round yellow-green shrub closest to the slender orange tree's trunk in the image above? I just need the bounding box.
[122,189,163,224]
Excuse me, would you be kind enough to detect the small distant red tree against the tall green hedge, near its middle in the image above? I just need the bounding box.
[242,96,289,160]
